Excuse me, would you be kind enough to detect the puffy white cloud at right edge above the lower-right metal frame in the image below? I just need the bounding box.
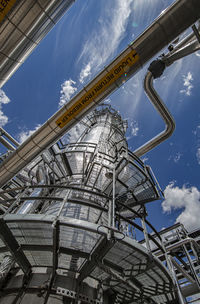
[162,182,200,230]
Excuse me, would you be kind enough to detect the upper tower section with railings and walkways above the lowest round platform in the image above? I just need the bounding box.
[0,105,160,215]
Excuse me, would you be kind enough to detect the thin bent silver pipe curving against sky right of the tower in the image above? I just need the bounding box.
[133,71,175,157]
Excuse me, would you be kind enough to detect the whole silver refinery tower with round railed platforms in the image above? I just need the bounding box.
[0,105,176,304]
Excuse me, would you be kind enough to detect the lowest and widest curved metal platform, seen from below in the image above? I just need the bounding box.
[0,215,175,303]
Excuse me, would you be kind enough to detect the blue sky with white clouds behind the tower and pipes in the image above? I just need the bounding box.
[0,0,200,233]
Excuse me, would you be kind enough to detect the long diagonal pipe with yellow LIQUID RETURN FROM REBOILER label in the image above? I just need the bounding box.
[0,0,200,187]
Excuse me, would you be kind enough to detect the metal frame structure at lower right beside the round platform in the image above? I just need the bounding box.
[147,223,200,303]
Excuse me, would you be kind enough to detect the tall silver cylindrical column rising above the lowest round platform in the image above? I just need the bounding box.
[43,106,128,225]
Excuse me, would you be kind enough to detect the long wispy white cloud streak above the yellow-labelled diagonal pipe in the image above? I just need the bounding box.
[79,0,133,83]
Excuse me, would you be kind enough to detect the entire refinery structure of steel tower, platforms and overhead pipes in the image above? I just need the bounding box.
[0,0,200,304]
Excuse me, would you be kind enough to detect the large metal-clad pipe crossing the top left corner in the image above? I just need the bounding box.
[0,0,75,87]
